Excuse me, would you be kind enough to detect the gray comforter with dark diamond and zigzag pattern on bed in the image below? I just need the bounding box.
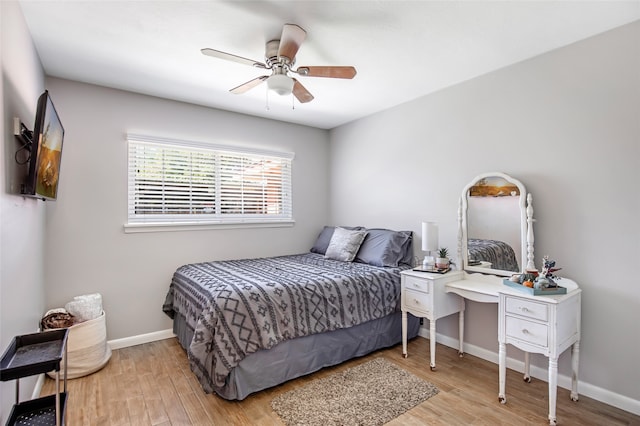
[163,253,403,392]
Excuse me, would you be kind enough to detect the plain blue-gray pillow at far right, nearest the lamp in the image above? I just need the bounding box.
[355,229,413,267]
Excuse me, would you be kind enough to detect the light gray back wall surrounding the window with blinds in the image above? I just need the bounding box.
[45,79,329,340]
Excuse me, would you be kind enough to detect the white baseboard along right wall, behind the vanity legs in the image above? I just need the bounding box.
[419,327,640,415]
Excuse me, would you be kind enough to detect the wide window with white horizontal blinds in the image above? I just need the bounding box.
[125,135,293,232]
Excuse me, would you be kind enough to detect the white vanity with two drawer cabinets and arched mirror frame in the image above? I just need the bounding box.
[402,173,581,425]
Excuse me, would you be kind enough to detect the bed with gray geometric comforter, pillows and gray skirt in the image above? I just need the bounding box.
[163,227,419,400]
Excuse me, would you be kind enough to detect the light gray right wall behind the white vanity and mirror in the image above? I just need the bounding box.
[330,22,640,409]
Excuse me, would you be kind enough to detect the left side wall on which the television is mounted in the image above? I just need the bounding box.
[0,1,45,424]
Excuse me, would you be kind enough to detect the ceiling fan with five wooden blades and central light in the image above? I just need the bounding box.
[201,24,356,103]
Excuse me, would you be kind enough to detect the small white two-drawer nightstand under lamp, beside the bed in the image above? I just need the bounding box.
[401,270,464,370]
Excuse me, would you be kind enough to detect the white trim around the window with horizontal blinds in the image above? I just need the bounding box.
[124,133,295,233]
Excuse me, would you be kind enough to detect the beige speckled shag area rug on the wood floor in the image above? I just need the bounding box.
[271,358,438,426]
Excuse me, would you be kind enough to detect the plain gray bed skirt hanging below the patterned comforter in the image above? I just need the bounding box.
[173,312,420,400]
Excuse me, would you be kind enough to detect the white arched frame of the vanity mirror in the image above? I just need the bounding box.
[458,172,536,276]
